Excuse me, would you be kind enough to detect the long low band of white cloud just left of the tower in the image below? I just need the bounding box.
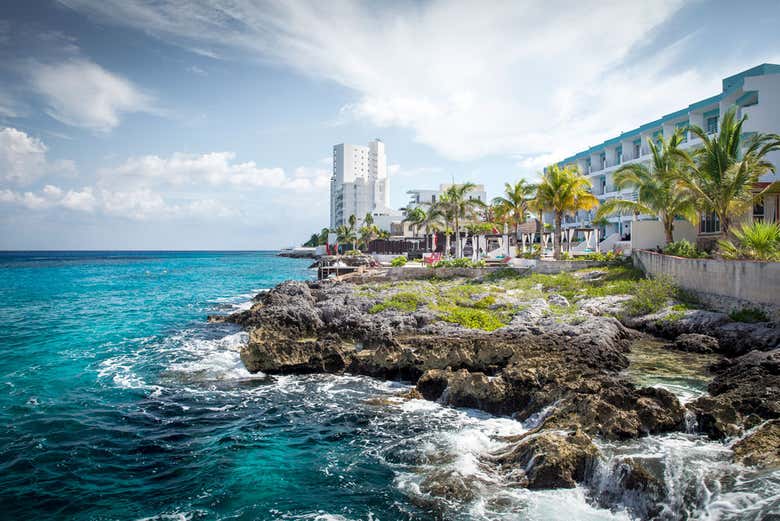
[100,152,330,191]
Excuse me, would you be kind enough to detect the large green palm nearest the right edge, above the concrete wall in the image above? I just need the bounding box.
[681,107,780,237]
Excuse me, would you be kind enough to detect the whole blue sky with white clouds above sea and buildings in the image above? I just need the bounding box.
[0,0,780,249]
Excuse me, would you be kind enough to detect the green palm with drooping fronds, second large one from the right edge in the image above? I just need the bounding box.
[596,131,696,244]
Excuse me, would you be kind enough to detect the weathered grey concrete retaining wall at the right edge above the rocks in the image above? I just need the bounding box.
[633,250,780,318]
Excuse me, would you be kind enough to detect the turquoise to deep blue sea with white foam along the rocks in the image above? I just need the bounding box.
[0,252,780,521]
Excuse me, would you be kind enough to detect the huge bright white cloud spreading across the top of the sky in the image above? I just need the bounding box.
[63,0,726,168]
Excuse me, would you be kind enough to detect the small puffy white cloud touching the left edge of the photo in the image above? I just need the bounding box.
[0,127,75,185]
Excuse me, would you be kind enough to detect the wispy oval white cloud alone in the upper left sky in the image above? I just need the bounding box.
[28,58,154,132]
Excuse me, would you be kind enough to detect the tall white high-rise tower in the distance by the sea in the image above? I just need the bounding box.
[330,139,400,230]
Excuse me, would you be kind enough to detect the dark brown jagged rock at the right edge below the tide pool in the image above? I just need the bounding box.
[689,349,780,439]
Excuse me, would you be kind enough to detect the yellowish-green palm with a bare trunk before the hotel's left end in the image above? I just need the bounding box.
[536,165,599,259]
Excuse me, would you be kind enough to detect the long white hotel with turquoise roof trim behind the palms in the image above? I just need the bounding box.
[558,63,780,242]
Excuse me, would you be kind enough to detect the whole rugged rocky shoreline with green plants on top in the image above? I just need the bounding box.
[211,270,780,516]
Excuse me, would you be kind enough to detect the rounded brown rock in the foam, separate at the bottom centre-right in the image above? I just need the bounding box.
[496,431,599,489]
